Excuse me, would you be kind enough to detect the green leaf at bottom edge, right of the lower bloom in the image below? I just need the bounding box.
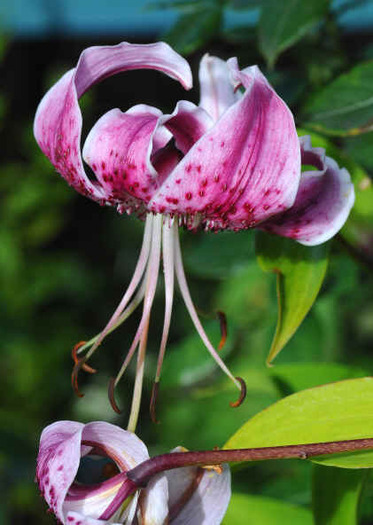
[223,494,312,525]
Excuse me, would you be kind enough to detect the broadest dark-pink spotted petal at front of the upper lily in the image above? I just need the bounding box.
[149,64,300,230]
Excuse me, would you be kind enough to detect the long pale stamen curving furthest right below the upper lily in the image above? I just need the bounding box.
[175,230,243,396]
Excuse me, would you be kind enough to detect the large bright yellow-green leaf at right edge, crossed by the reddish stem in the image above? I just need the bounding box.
[224,378,373,468]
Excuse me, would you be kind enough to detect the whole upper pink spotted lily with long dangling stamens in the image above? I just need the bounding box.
[34,43,354,416]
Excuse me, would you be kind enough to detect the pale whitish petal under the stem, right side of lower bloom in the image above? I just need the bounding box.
[165,458,231,525]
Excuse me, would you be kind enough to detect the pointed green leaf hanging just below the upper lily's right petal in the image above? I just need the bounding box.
[256,232,328,363]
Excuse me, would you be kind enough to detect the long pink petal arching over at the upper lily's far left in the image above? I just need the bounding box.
[34,42,192,203]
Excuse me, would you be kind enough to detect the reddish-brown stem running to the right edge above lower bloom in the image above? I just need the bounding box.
[127,438,373,487]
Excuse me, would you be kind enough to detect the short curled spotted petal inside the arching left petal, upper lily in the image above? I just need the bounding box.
[83,105,162,204]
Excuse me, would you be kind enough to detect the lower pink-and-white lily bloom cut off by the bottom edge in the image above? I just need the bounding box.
[36,421,231,525]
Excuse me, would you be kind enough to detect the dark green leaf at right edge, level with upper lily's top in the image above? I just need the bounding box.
[305,60,373,136]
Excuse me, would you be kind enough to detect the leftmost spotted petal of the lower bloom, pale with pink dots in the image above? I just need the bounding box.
[36,421,84,523]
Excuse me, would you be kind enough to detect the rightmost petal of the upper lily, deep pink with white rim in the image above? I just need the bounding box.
[263,133,355,246]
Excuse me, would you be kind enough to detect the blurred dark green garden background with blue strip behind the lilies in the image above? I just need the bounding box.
[0,0,373,525]
